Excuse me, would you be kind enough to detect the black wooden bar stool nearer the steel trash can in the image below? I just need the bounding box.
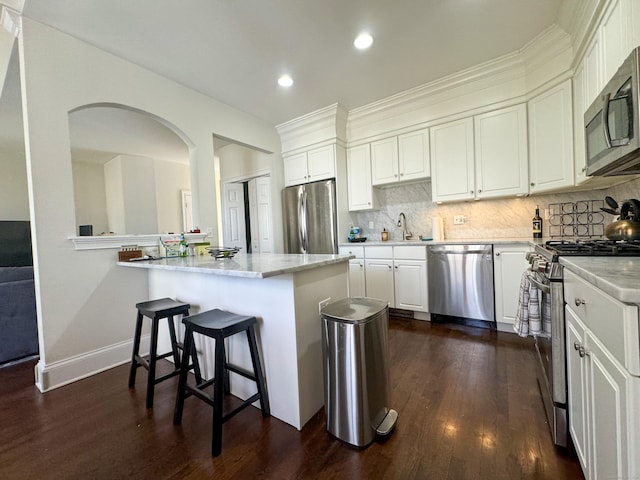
[173,309,270,457]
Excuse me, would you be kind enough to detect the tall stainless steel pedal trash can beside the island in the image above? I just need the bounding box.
[320,297,398,447]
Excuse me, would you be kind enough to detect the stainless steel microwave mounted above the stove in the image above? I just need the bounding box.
[584,47,640,176]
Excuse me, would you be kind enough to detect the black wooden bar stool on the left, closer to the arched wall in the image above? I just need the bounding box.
[129,298,202,408]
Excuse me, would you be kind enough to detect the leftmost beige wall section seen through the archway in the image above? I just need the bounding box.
[73,162,109,235]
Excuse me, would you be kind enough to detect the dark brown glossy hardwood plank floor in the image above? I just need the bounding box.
[0,319,583,480]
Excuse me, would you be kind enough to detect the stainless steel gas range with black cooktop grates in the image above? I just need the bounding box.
[527,240,640,447]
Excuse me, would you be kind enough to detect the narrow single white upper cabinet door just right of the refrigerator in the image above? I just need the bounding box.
[347,144,377,211]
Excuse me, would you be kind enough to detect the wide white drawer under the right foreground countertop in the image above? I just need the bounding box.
[564,268,640,375]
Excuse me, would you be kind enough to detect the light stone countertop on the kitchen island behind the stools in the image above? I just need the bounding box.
[118,253,353,278]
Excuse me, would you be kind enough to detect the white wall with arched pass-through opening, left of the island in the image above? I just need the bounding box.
[19,18,280,390]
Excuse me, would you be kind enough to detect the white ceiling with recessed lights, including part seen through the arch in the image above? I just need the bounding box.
[0,0,580,163]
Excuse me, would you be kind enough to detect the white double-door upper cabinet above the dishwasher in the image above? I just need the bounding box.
[430,104,528,202]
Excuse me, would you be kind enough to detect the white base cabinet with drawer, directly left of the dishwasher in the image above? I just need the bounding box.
[393,246,428,312]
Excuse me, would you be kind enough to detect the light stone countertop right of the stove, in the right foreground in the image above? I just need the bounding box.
[560,256,640,305]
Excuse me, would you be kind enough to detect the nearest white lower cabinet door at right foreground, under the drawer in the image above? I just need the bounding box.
[586,331,638,479]
